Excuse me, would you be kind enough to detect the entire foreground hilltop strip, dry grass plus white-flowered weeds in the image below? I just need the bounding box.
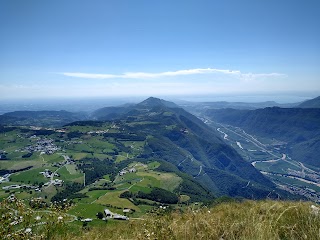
[0,195,320,240]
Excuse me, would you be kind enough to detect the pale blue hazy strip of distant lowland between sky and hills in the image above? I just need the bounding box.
[0,91,317,115]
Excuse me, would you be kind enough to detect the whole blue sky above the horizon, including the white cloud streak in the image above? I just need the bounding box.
[0,0,320,99]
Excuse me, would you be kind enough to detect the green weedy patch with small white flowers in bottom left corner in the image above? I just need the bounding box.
[0,197,72,240]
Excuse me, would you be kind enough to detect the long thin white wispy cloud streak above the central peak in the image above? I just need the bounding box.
[59,68,287,81]
